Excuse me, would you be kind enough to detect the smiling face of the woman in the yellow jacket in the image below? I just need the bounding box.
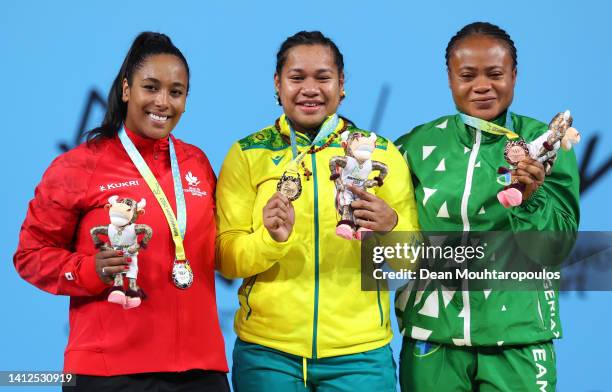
[274,45,344,133]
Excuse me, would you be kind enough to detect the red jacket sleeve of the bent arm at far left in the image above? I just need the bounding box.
[13,147,107,296]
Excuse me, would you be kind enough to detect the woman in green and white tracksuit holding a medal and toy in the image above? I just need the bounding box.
[395,22,579,392]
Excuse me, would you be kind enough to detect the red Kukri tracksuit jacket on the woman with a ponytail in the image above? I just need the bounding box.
[14,131,227,376]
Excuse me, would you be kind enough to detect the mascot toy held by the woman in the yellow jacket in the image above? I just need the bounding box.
[329,131,388,240]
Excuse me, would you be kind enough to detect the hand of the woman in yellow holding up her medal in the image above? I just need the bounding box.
[263,192,295,242]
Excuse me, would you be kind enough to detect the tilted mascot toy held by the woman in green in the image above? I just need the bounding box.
[497,110,580,208]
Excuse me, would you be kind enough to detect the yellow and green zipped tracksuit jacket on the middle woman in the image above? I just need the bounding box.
[217,115,418,358]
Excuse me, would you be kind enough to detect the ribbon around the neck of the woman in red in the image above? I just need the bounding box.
[119,127,187,261]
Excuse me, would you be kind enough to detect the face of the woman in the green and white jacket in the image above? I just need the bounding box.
[448,35,516,121]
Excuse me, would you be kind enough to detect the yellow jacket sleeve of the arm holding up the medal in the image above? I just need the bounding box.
[216,143,291,278]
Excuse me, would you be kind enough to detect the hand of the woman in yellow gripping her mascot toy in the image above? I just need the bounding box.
[348,185,397,232]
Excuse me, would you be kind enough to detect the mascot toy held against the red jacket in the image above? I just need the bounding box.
[90,196,153,309]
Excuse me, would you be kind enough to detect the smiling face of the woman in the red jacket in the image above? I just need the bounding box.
[122,54,188,139]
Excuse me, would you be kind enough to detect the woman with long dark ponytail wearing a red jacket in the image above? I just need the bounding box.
[14,32,229,391]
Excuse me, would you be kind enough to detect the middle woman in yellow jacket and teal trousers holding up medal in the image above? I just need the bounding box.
[217,32,417,392]
